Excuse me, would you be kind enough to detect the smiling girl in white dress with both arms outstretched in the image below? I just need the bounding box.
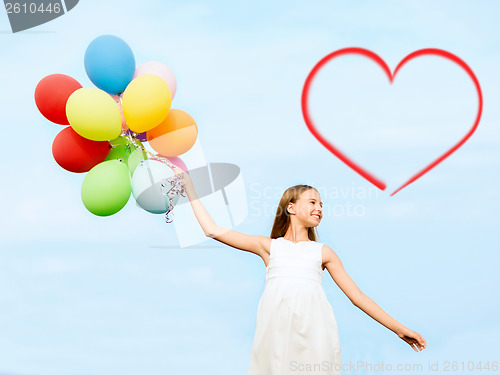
[175,168,427,375]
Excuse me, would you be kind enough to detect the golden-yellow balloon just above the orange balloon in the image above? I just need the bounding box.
[122,74,172,133]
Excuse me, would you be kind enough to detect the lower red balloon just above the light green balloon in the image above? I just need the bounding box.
[52,126,111,173]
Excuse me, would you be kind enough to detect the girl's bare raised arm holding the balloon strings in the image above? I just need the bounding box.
[174,168,271,263]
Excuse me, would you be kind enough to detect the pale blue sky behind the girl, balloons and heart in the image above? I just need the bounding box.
[0,0,500,375]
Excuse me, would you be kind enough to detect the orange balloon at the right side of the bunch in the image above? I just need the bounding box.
[146,109,198,156]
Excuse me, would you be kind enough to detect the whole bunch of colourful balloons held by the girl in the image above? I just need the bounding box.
[35,35,198,219]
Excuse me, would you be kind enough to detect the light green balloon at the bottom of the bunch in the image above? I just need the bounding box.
[82,160,132,216]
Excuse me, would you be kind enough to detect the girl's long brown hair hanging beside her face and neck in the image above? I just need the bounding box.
[270,185,318,241]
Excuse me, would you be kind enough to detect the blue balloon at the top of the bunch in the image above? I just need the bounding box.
[84,35,135,95]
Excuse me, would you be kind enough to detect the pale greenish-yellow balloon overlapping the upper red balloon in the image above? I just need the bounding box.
[66,87,122,141]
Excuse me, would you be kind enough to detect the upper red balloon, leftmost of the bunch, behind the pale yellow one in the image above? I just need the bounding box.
[35,74,82,125]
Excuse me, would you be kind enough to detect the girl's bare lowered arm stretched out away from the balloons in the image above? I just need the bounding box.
[322,245,427,352]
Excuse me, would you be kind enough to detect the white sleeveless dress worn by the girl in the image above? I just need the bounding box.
[248,237,341,375]
